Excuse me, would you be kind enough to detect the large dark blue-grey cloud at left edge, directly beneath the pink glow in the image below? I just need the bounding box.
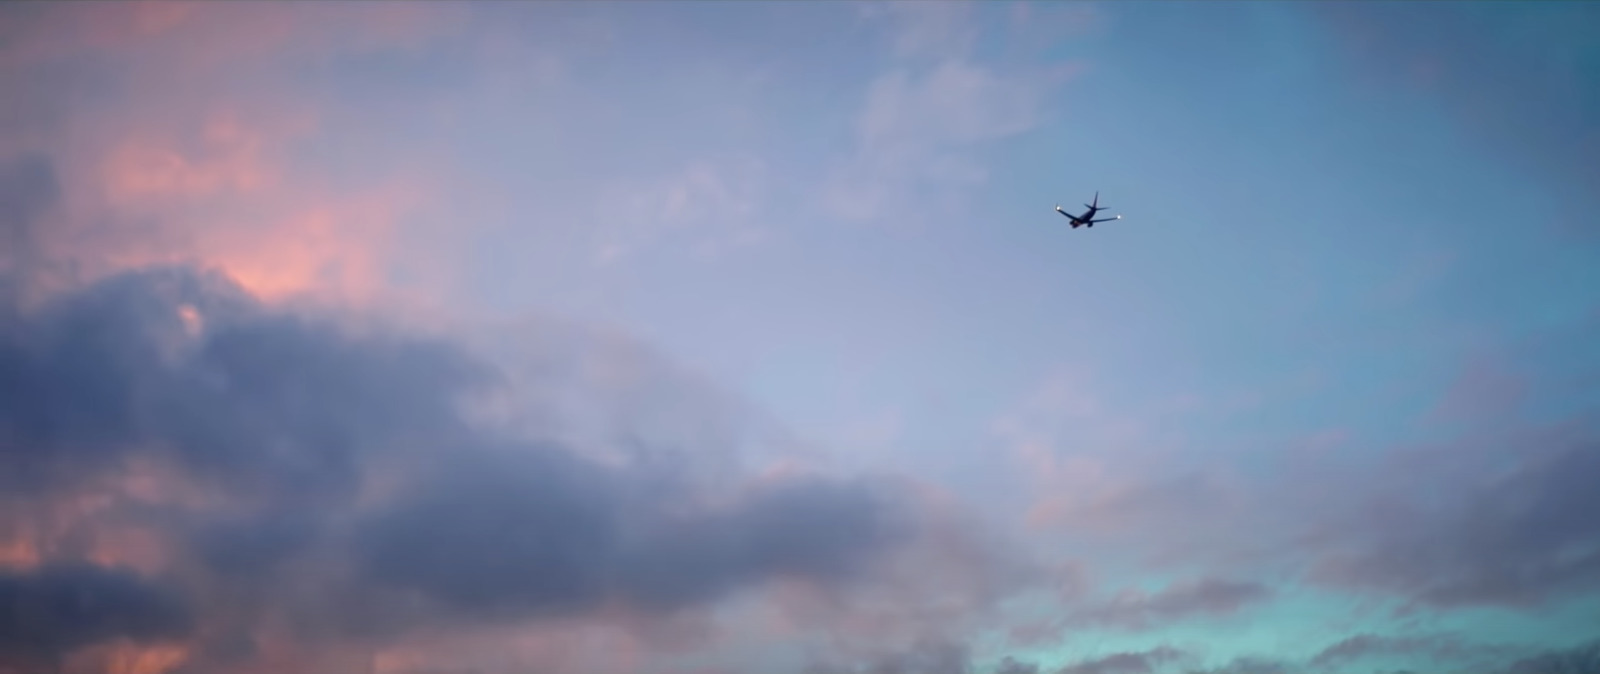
[0,262,482,501]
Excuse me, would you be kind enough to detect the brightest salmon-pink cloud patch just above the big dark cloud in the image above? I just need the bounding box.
[69,111,443,301]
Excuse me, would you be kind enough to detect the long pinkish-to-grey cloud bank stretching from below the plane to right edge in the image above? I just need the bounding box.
[1000,322,1600,616]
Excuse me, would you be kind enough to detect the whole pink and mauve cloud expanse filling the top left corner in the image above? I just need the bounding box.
[0,3,464,303]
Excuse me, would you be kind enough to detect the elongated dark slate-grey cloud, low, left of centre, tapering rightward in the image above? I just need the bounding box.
[355,448,906,633]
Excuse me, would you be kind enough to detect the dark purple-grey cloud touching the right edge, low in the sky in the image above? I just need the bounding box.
[1314,429,1600,607]
